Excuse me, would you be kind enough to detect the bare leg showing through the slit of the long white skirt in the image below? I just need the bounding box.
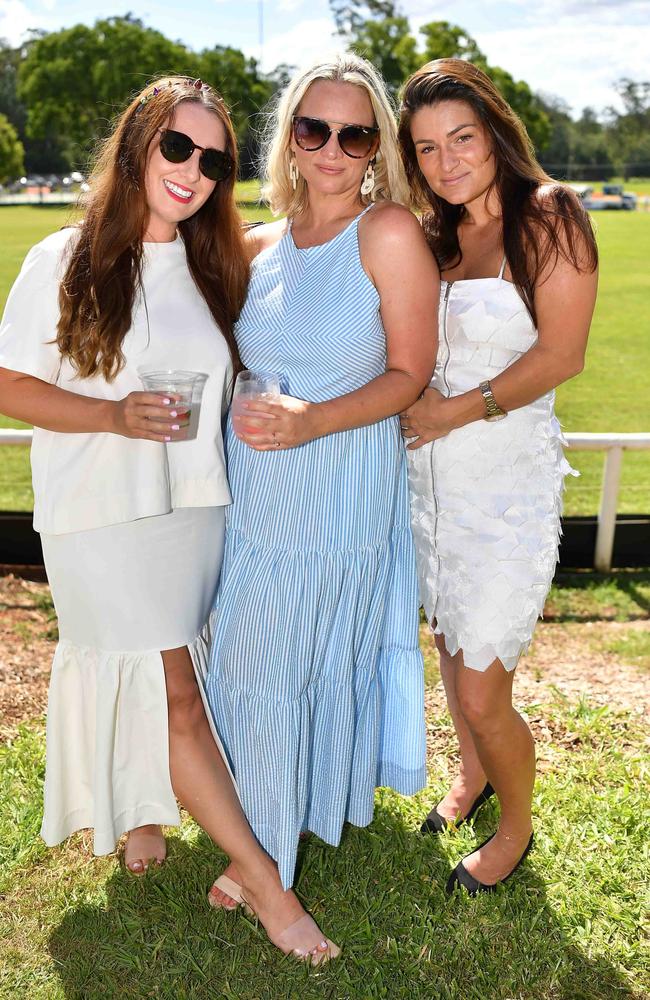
[162,646,334,958]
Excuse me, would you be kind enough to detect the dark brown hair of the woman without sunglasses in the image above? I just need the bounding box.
[398,59,598,323]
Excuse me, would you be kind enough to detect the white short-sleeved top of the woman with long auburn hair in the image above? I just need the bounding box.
[0,229,231,534]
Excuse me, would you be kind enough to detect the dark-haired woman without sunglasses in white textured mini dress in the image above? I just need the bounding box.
[400,59,597,894]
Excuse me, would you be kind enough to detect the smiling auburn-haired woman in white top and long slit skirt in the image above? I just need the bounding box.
[0,77,334,962]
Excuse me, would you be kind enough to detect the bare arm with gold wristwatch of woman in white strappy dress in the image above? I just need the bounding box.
[403,216,598,448]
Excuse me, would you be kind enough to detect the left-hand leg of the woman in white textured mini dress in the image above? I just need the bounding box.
[435,635,486,820]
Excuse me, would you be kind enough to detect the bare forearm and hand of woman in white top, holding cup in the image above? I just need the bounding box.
[0,368,186,441]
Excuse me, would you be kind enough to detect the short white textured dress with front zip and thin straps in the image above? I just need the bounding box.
[408,261,576,670]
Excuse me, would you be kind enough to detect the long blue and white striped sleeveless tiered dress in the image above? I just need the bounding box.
[207,207,425,887]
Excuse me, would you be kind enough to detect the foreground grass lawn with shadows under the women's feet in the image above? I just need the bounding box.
[0,571,650,1000]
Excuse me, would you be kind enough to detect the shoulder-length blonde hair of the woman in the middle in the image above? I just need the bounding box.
[261,52,410,217]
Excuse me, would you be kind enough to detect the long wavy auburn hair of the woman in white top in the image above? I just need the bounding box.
[56,77,248,382]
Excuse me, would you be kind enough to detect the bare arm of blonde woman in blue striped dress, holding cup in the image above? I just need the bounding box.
[238,205,440,450]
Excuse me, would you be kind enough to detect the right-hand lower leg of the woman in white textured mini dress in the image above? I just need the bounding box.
[456,660,535,884]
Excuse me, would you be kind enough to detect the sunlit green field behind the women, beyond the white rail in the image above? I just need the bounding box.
[0,189,650,514]
